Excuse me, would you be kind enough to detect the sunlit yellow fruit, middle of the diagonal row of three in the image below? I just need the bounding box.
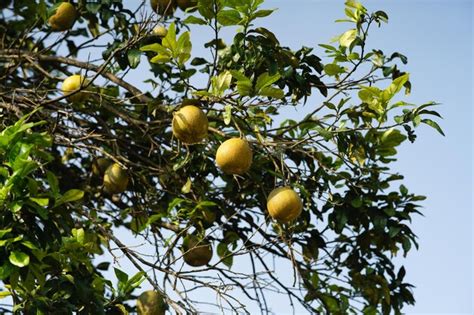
[216,138,253,174]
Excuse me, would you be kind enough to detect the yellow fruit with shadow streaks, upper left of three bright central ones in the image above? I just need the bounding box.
[172,105,209,144]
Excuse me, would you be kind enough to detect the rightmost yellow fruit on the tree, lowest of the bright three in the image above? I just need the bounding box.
[267,187,303,223]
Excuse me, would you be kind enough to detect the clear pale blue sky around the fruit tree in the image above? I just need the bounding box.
[117,0,474,314]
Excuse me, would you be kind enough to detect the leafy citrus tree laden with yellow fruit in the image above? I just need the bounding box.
[0,0,442,314]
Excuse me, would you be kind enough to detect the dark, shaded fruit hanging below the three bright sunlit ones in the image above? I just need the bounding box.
[183,235,212,267]
